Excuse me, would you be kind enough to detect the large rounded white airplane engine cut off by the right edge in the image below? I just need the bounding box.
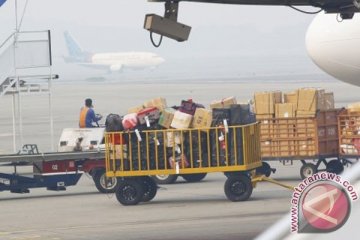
[306,13,360,86]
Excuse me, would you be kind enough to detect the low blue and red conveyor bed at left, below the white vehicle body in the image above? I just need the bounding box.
[0,145,104,193]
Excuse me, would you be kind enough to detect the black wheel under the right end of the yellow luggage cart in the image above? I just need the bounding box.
[224,175,253,202]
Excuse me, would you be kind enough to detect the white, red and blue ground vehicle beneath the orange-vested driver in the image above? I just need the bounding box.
[0,128,116,193]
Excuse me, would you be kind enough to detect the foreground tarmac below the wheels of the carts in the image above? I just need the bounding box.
[0,163,300,240]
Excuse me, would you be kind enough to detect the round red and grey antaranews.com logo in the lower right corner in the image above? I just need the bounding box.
[291,172,359,233]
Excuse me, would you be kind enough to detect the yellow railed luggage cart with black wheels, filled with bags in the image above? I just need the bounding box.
[105,123,262,205]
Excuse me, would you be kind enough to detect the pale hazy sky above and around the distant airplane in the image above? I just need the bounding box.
[0,0,326,80]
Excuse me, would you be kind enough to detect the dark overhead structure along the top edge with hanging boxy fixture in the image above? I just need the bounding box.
[144,0,360,47]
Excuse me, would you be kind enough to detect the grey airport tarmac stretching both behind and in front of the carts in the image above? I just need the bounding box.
[0,81,358,240]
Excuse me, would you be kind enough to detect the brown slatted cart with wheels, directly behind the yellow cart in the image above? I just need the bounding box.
[258,109,347,178]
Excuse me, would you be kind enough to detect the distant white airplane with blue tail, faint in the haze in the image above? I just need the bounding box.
[64,32,165,72]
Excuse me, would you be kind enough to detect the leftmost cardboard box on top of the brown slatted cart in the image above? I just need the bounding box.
[254,91,282,114]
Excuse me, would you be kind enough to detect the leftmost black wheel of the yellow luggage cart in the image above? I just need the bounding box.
[115,179,144,206]
